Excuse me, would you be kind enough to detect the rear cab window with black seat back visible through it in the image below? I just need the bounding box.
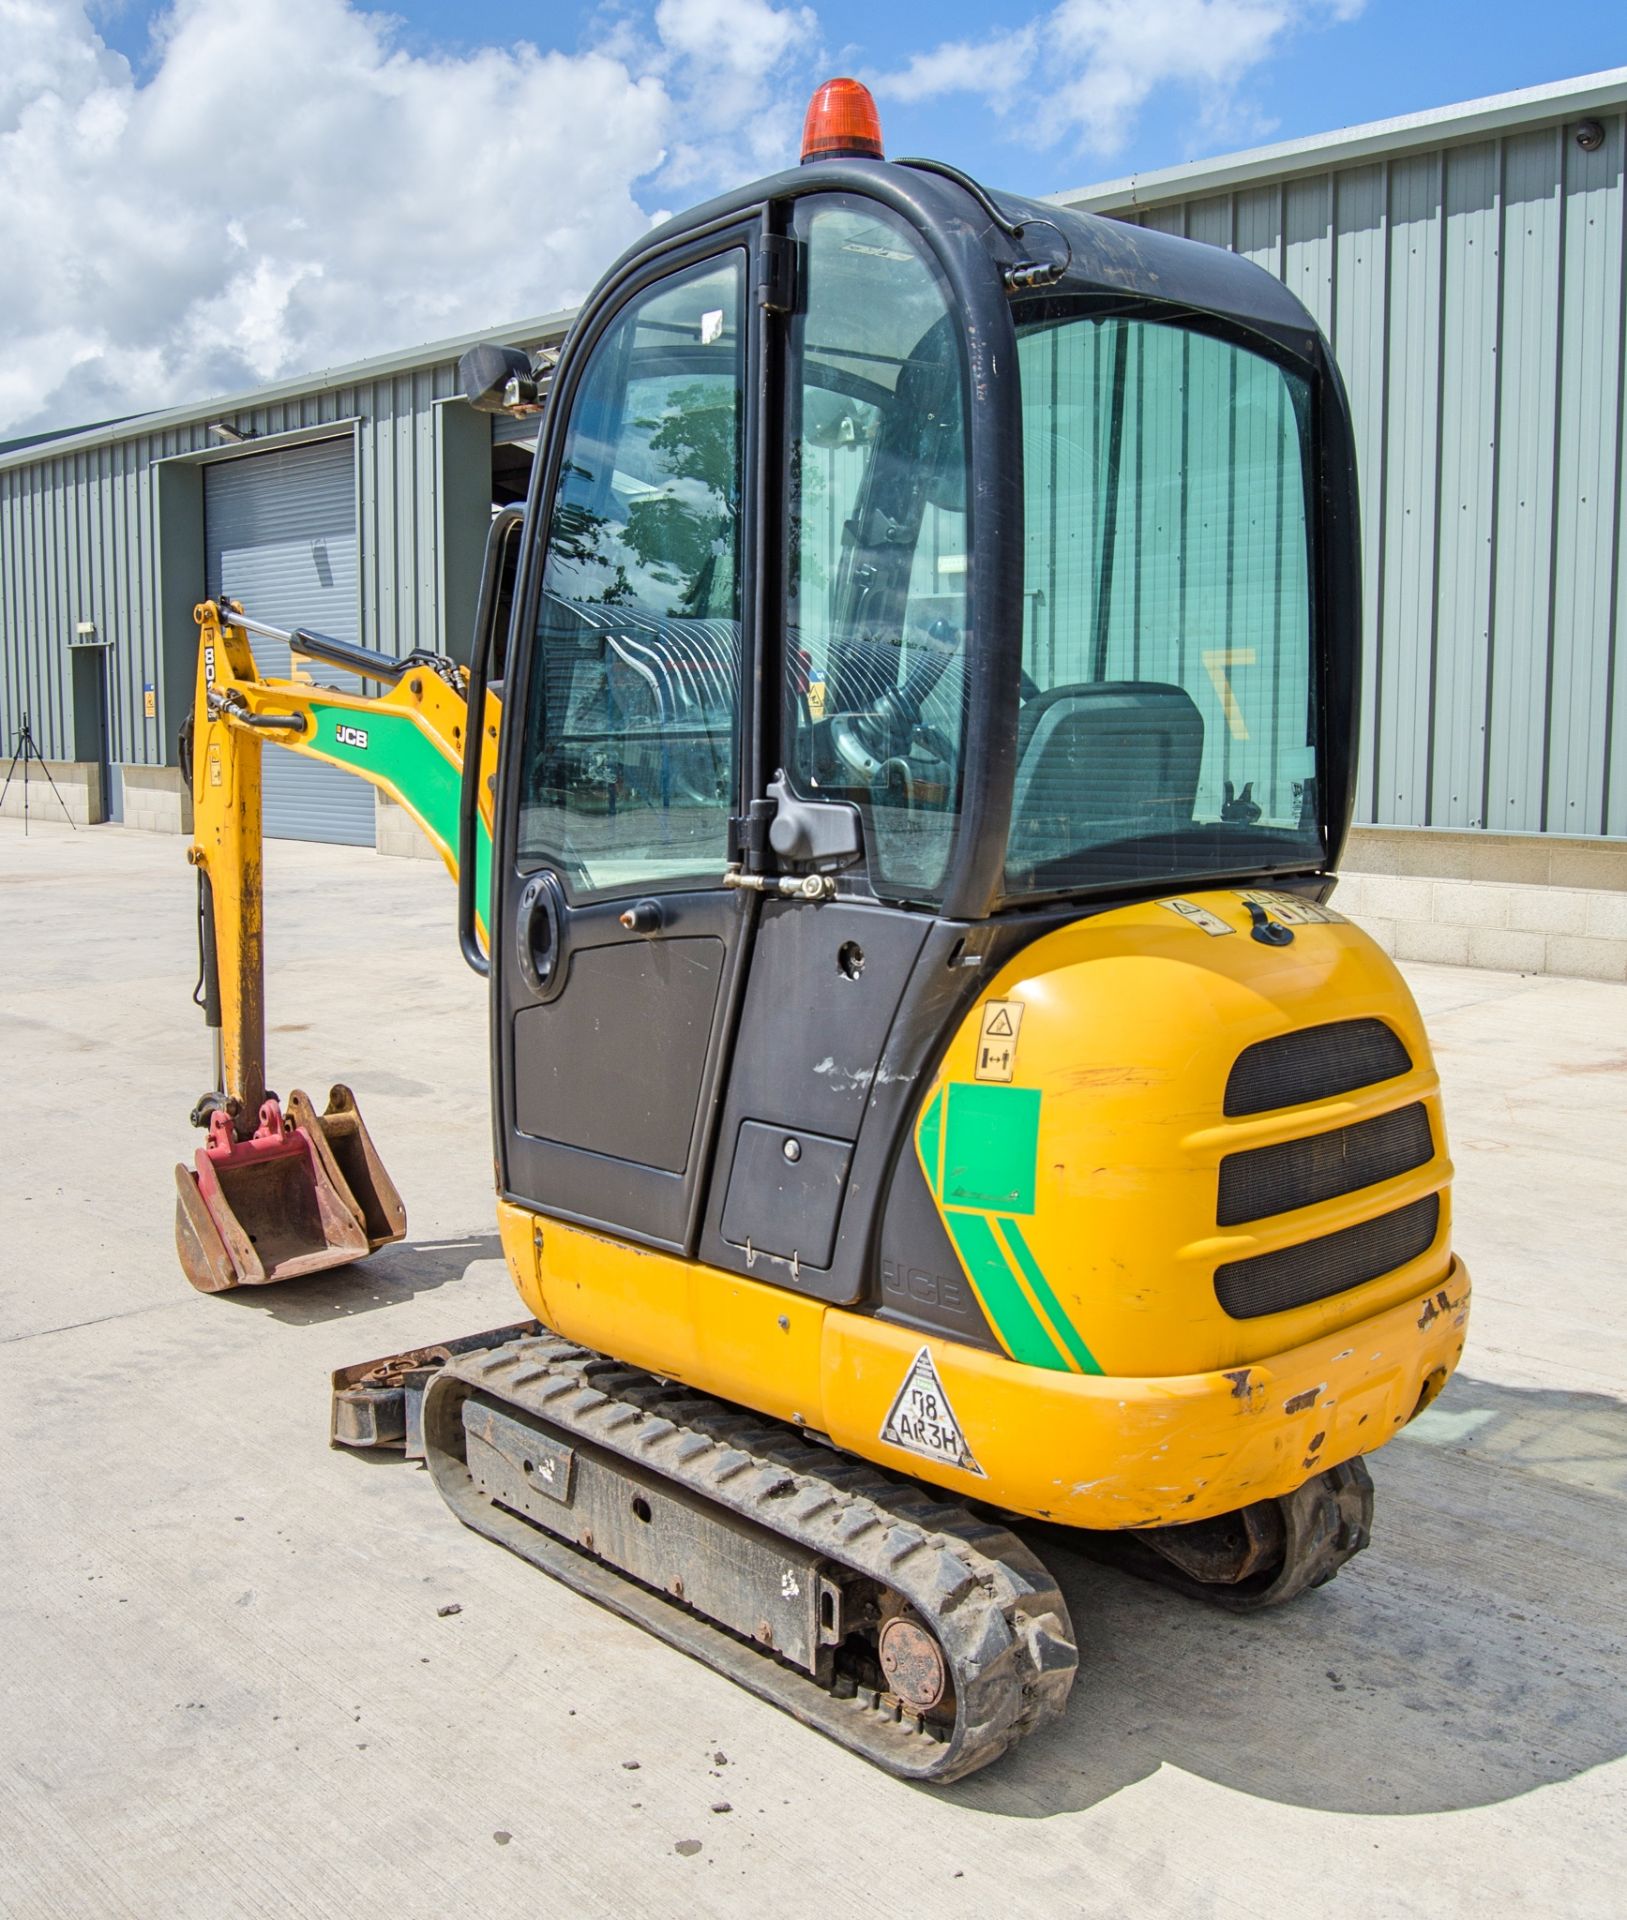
[1007,309,1323,895]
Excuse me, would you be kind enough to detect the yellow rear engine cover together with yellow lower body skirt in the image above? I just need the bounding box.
[499,891,1469,1528]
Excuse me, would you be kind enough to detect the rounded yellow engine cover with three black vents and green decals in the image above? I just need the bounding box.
[916,893,1452,1375]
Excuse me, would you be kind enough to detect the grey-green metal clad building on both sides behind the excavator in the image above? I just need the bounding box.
[0,69,1627,879]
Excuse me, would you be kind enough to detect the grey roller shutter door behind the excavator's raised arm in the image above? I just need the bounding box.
[204,447,373,847]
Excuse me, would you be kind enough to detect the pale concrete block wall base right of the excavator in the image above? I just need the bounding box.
[1333,828,1627,981]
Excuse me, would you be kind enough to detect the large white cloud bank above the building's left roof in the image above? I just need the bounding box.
[0,0,814,436]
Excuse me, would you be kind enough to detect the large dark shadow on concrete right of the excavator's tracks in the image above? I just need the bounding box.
[935,1375,1627,1818]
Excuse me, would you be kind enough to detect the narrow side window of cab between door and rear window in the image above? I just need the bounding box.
[784,196,970,902]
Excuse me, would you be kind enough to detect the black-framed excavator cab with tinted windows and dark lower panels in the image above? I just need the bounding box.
[492,108,1358,1305]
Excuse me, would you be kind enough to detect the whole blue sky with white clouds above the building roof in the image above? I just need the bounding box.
[0,0,1627,438]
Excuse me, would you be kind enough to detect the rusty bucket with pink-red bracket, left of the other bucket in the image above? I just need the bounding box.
[175,1096,370,1294]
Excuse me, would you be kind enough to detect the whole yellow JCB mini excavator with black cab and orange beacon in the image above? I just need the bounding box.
[177,81,1469,1780]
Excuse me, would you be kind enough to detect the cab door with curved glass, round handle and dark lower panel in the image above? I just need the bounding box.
[494,230,757,1250]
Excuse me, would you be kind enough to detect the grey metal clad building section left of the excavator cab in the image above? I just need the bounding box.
[0,315,569,843]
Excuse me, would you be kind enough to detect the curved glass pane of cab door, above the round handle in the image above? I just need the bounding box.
[519,252,745,897]
